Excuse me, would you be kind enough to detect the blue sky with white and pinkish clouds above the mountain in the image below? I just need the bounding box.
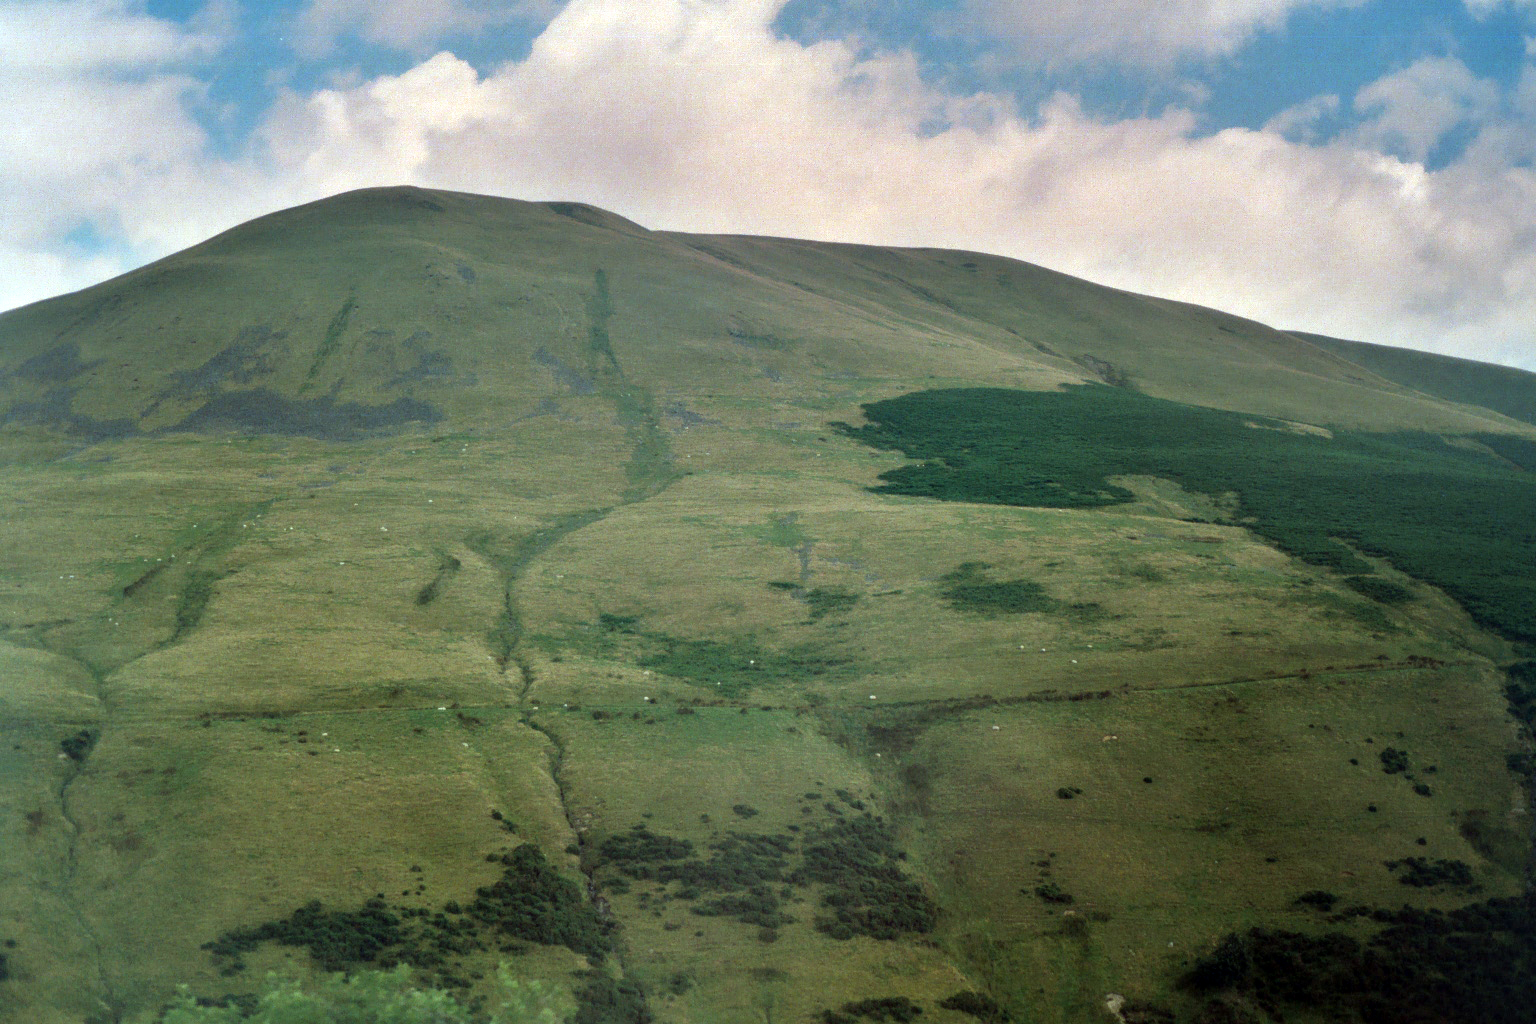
[0,0,1536,370]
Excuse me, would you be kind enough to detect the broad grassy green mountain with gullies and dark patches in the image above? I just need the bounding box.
[0,187,1536,1024]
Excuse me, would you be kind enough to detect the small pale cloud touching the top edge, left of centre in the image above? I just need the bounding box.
[293,0,559,57]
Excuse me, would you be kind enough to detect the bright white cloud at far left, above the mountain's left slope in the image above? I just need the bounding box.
[0,0,242,306]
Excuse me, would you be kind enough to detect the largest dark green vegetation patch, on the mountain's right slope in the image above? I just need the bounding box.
[839,385,1536,642]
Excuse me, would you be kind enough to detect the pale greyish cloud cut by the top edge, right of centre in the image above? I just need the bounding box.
[965,0,1366,66]
